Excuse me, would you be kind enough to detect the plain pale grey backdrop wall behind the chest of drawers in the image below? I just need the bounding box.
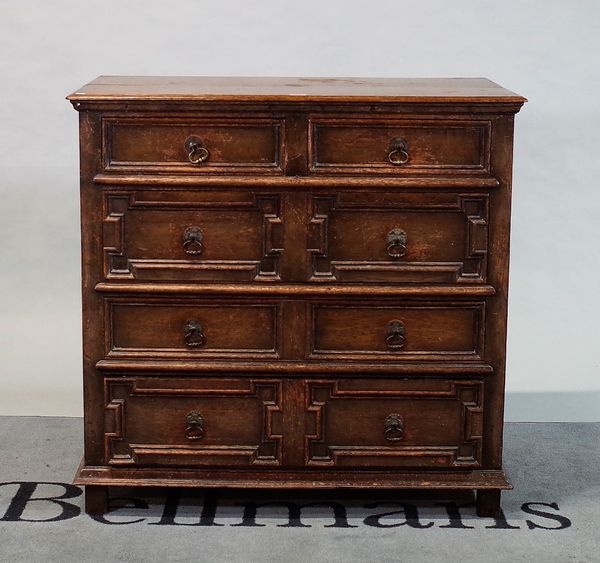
[0,0,600,421]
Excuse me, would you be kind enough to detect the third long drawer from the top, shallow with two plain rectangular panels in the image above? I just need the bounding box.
[104,294,486,364]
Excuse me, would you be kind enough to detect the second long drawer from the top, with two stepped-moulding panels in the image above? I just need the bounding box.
[102,188,489,283]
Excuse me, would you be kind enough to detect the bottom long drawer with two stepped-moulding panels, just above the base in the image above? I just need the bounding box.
[104,374,483,469]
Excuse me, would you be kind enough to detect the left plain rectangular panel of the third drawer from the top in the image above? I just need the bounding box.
[105,297,281,359]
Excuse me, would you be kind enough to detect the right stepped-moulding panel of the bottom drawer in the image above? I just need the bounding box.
[305,379,483,469]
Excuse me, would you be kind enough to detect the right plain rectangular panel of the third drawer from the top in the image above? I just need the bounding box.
[310,301,485,362]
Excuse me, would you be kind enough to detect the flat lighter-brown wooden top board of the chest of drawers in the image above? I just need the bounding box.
[67,76,526,104]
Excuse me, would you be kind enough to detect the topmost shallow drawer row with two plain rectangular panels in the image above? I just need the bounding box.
[103,113,491,176]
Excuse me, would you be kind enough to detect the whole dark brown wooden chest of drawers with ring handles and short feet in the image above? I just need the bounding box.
[68,77,525,515]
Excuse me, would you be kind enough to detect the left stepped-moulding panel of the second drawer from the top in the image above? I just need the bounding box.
[102,189,283,282]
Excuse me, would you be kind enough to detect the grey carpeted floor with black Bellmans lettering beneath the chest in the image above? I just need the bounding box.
[0,417,600,563]
